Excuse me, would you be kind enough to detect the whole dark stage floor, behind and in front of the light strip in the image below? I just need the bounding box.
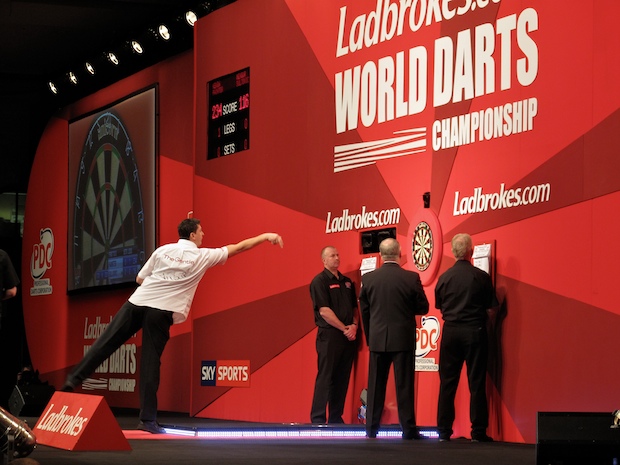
[17,411,536,465]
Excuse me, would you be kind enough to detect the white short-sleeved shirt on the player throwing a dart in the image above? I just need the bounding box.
[129,239,228,323]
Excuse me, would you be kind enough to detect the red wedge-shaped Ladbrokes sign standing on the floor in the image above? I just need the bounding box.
[32,392,131,451]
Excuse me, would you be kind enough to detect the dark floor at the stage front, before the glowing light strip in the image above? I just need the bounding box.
[24,439,536,465]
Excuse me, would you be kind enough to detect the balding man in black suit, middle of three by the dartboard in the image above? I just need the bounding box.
[360,238,428,439]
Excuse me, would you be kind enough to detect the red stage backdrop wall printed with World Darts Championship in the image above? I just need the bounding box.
[22,0,620,442]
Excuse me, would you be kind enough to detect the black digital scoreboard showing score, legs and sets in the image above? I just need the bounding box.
[207,68,250,160]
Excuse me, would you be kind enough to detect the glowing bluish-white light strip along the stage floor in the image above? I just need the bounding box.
[164,425,439,439]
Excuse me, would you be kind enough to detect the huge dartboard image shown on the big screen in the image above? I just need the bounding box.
[73,112,145,289]
